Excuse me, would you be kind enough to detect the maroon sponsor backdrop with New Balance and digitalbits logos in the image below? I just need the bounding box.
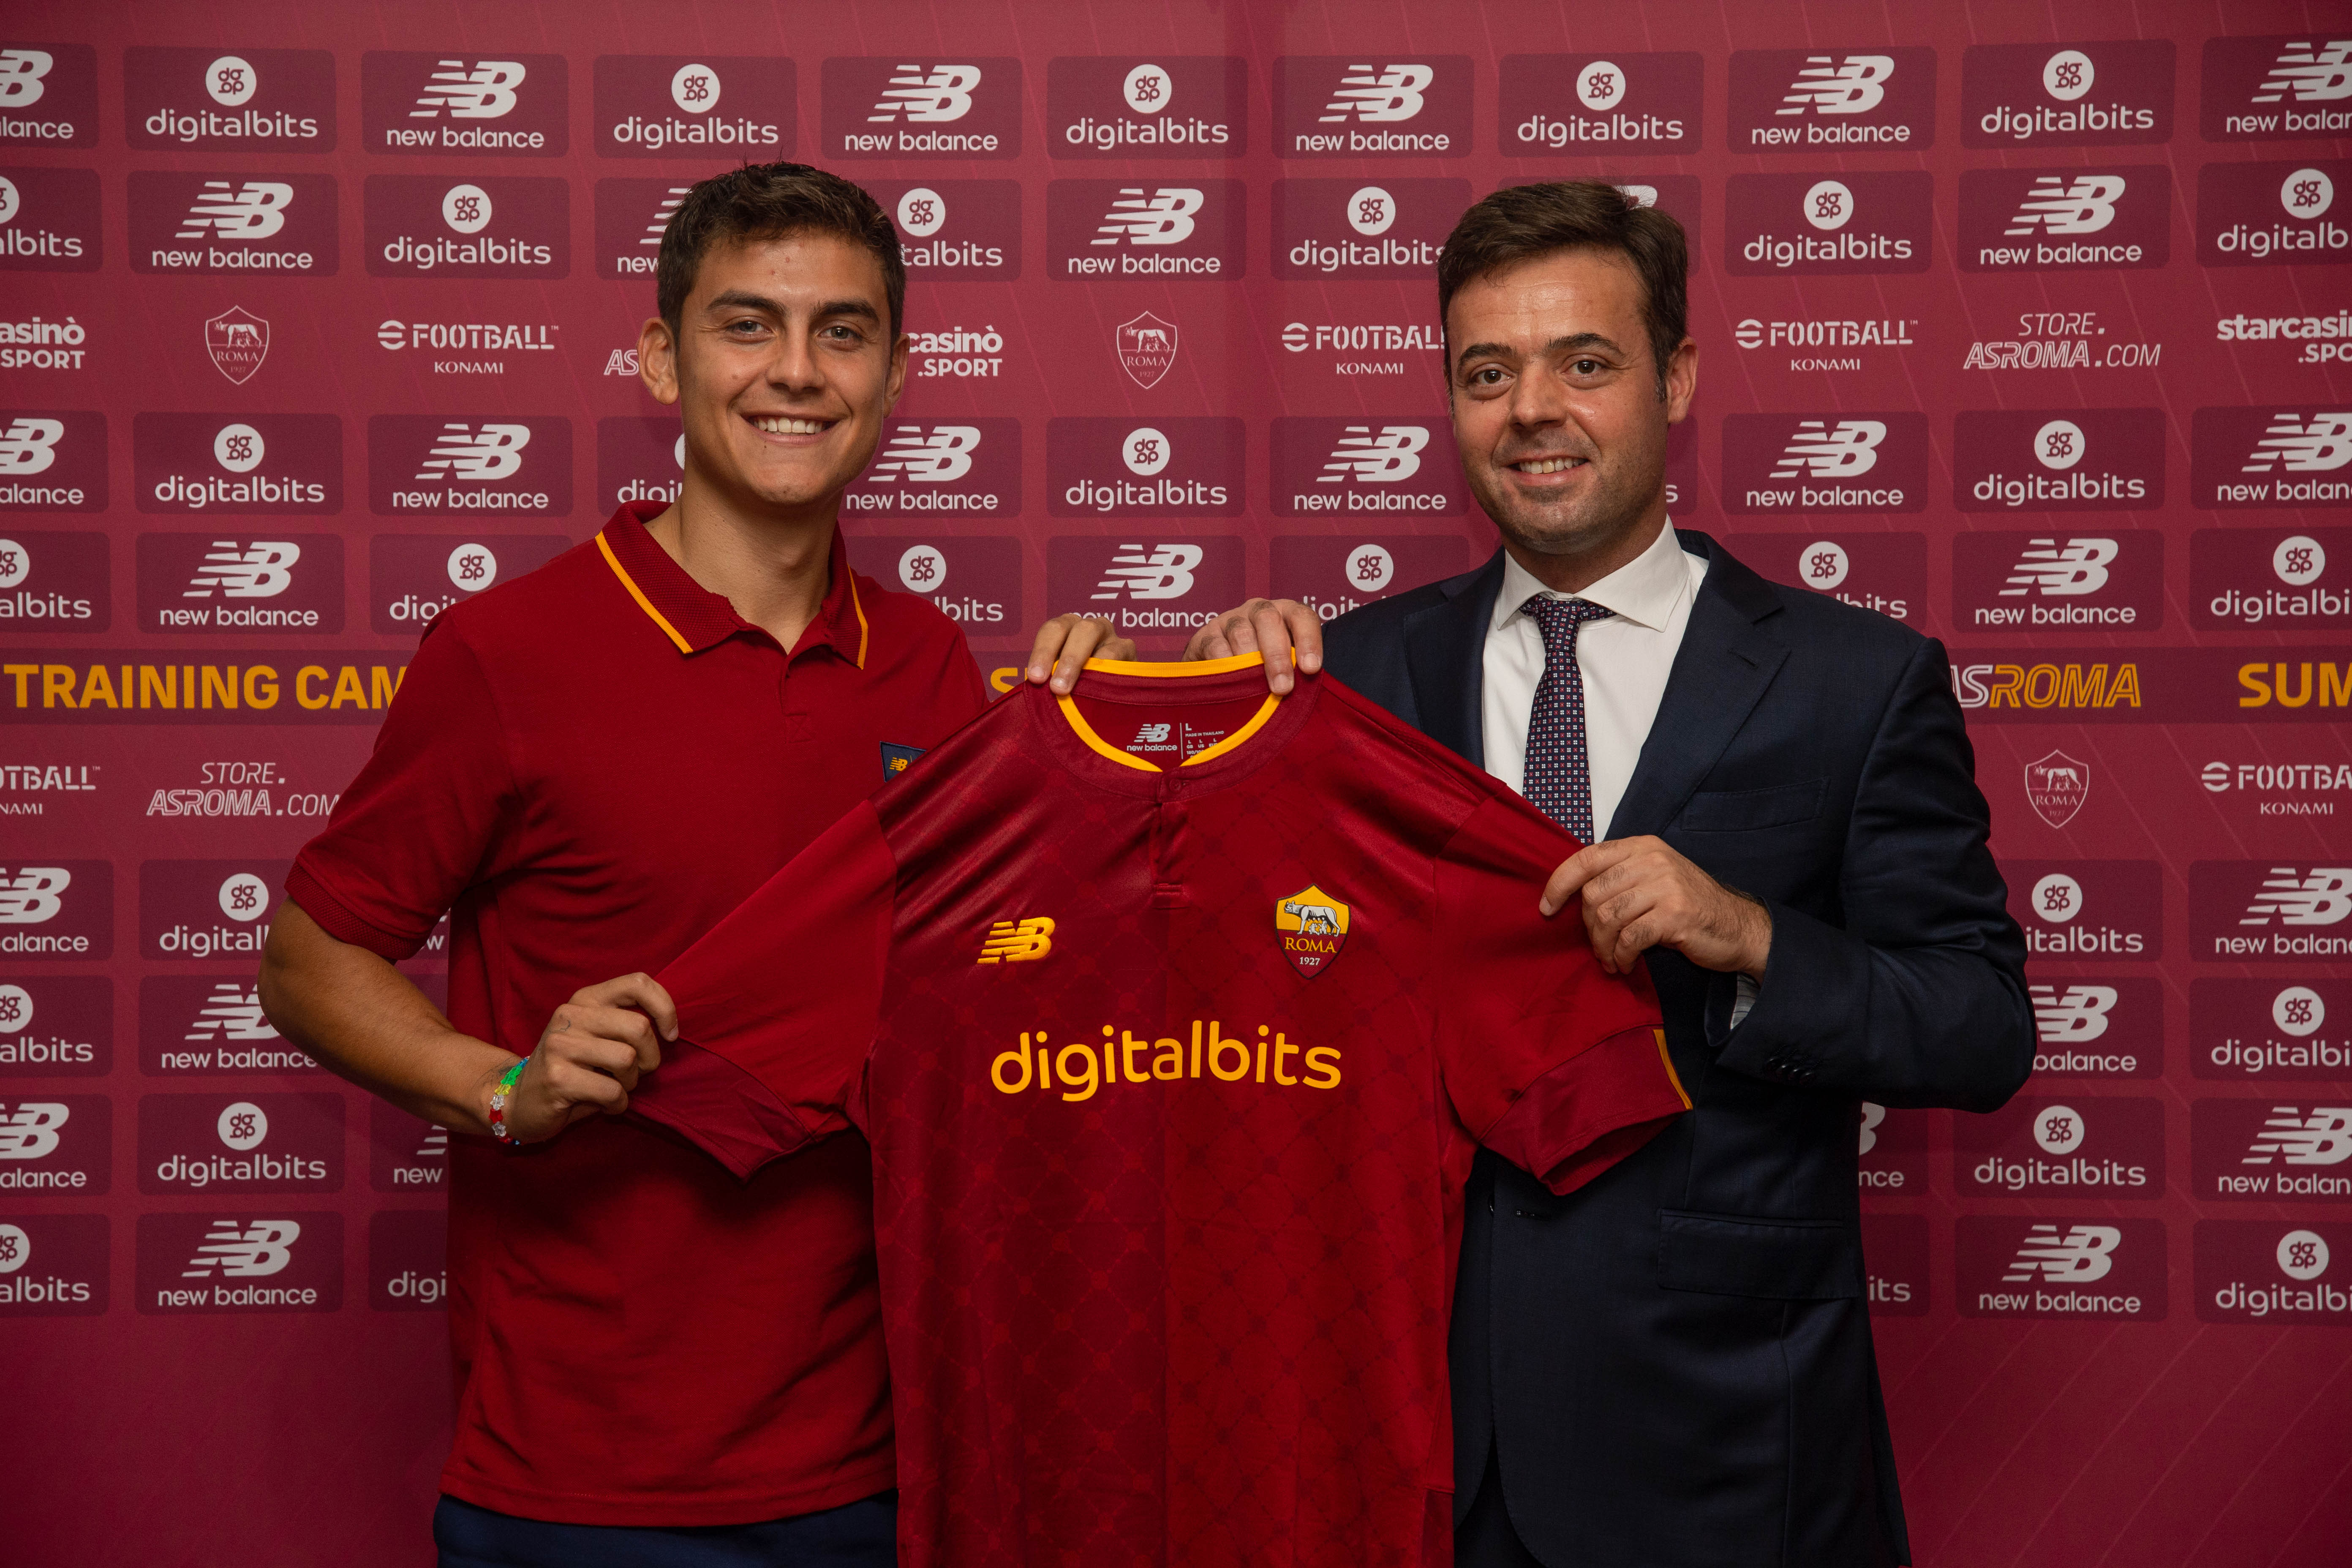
[0,0,2352,1565]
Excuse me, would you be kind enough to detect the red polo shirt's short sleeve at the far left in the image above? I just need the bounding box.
[287,623,517,964]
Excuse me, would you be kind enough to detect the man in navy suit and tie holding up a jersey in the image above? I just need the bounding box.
[1188,183,2034,1568]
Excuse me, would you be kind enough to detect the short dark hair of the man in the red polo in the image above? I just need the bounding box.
[654,162,906,341]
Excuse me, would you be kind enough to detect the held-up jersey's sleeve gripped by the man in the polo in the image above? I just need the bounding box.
[630,804,898,1176]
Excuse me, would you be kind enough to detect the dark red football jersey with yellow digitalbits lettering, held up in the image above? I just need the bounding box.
[635,656,1689,1568]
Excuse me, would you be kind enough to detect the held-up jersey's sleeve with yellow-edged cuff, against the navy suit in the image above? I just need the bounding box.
[1432,799,1691,1194]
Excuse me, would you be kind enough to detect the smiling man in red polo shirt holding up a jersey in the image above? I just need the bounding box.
[261,165,1166,1568]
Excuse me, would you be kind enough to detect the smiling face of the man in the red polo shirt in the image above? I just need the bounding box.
[637,233,906,517]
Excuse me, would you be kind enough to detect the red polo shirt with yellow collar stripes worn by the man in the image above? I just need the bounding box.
[287,506,985,1526]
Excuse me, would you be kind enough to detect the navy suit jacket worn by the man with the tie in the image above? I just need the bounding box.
[1324,531,2034,1568]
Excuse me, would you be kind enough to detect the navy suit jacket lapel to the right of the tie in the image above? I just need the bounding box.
[1609,529,1788,839]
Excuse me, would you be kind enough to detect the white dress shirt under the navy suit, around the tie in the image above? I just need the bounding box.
[1479,522,1707,837]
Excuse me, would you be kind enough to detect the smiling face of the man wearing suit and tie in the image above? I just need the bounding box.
[1446,249,1698,592]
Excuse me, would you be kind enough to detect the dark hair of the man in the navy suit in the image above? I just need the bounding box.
[1437,179,1691,397]
